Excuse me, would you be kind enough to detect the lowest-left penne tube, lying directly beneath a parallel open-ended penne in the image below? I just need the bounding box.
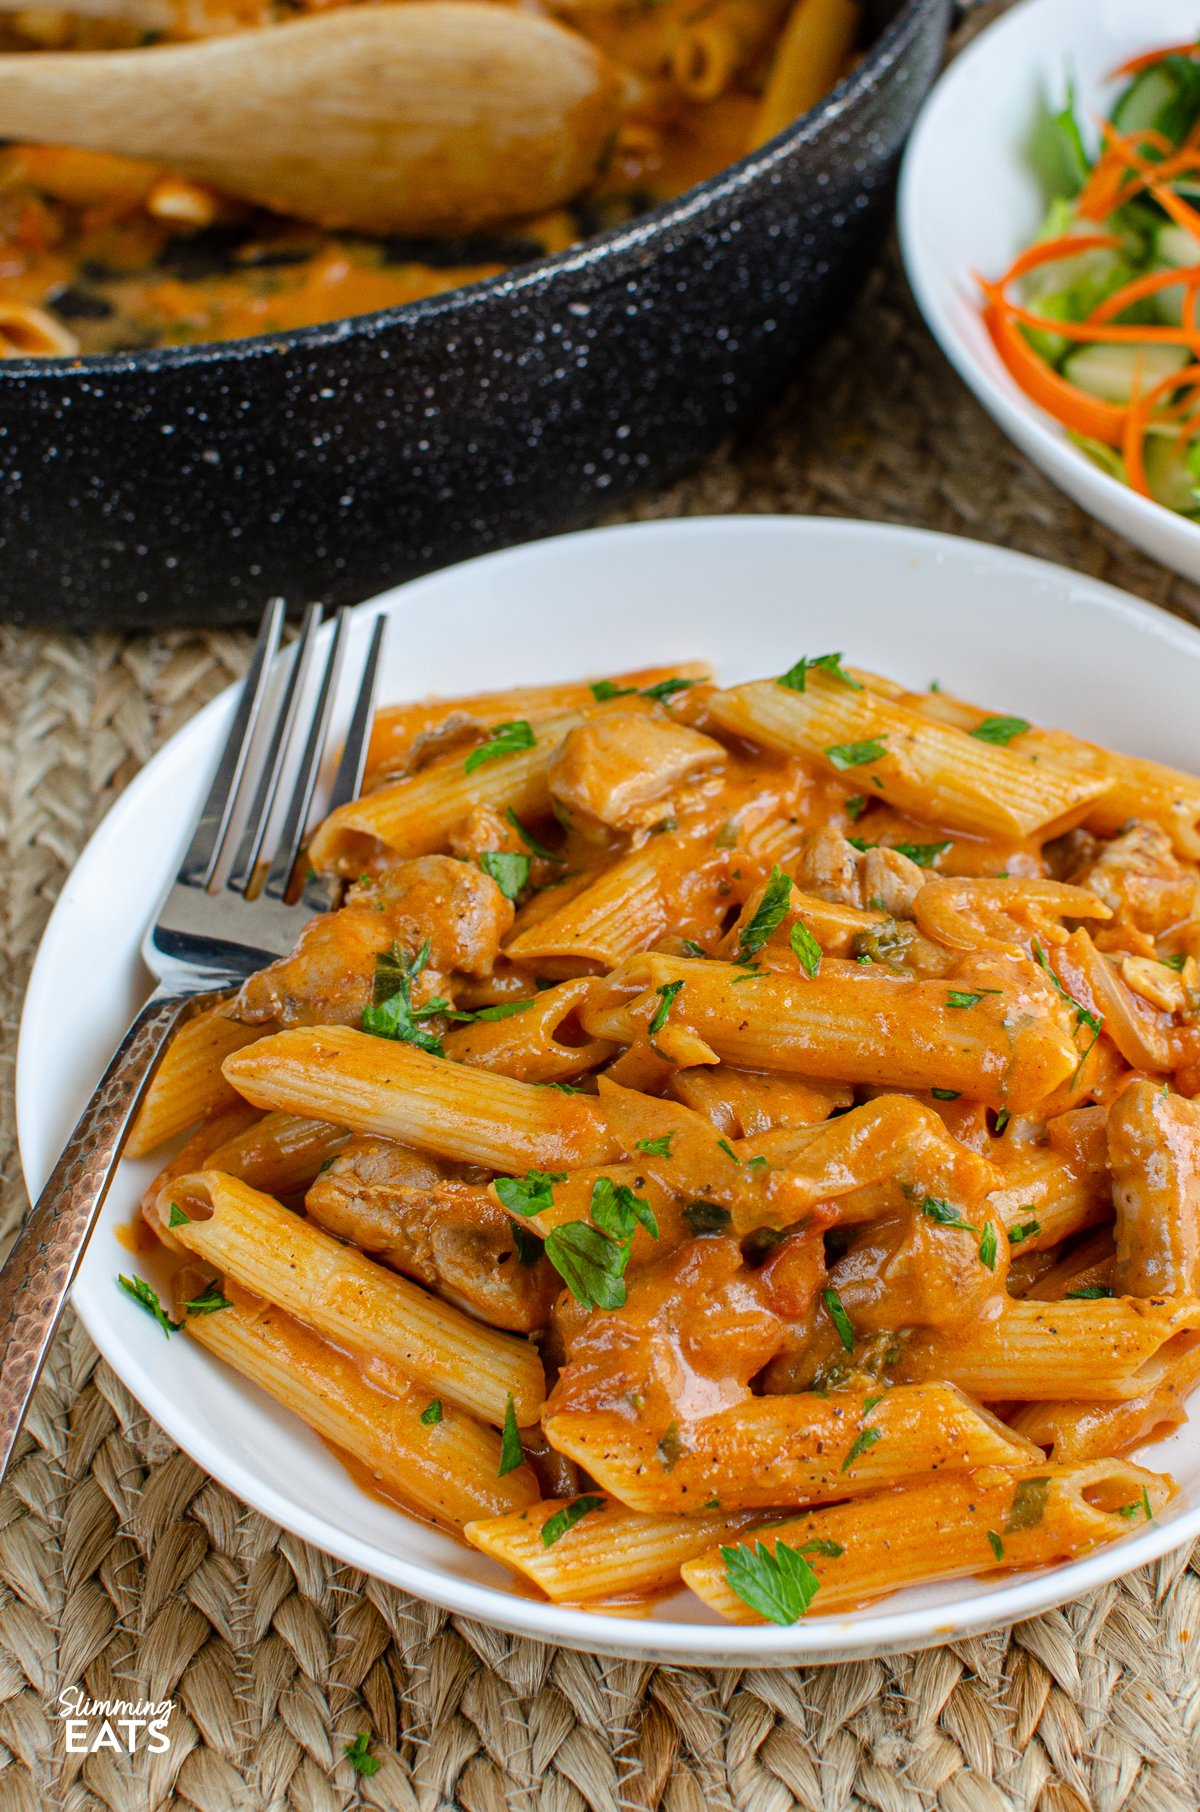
[187,1285,537,1529]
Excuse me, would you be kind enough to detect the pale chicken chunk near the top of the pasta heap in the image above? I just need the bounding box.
[549,710,727,830]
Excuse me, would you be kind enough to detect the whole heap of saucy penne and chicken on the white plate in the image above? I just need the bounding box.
[121,654,1200,1624]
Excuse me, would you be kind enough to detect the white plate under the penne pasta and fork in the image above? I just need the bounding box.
[16,516,1200,1665]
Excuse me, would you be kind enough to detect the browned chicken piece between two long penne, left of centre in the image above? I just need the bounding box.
[305,1138,560,1334]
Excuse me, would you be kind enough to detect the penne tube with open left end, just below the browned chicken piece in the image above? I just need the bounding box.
[170,1171,546,1428]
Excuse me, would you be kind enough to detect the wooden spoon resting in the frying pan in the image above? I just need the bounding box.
[0,0,624,234]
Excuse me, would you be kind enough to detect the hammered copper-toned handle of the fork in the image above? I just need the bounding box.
[0,993,219,1480]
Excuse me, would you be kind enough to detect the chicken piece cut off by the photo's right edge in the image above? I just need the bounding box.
[1108,1082,1200,1296]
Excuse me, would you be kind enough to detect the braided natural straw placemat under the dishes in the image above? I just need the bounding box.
[0,10,1200,1812]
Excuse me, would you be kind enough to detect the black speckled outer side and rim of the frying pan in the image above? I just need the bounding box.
[0,0,950,629]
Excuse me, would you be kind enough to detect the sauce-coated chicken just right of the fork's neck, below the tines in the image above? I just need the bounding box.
[237,855,513,1027]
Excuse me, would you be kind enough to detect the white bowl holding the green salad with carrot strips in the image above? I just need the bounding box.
[899,0,1200,582]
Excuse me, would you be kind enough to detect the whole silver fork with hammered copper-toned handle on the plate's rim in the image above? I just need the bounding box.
[0,598,384,1480]
